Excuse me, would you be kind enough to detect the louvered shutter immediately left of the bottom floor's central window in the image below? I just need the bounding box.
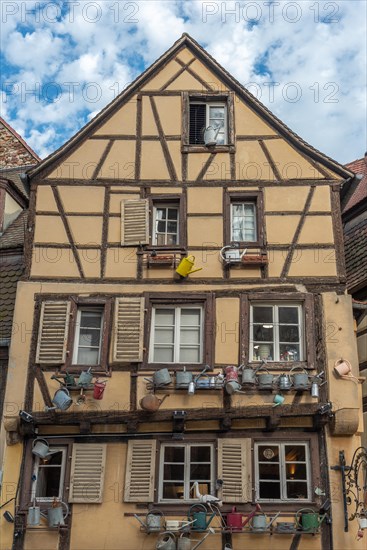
[124,440,157,502]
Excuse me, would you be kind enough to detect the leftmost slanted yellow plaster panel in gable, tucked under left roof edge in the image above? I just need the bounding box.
[48,139,108,179]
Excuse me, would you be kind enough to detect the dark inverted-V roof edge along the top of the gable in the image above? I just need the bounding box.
[29,33,353,179]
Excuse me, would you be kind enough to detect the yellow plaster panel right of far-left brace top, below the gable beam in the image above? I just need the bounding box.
[58,190,105,214]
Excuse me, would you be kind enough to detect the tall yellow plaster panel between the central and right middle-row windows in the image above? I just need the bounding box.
[215,298,241,365]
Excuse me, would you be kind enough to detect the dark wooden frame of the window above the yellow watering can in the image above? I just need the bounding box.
[145,194,187,251]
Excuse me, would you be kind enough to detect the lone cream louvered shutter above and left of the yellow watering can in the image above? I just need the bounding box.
[121,199,149,245]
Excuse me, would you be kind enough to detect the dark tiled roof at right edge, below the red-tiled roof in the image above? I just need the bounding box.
[344,216,367,291]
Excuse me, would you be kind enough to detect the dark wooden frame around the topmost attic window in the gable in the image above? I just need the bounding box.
[181,92,235,153]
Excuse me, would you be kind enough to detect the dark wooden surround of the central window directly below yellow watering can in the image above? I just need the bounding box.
[141,293,215,371]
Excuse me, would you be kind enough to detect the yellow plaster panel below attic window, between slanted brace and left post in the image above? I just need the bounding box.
[97,140,135,180]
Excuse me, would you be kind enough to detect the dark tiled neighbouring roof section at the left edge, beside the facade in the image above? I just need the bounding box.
[0,256,24,340]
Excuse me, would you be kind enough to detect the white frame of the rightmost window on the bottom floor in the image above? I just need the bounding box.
[253,439,312,504]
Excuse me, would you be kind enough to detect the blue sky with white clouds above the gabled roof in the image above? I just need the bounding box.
[0,0,367,163]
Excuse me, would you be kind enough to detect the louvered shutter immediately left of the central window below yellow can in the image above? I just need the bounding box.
[112,297,144,363]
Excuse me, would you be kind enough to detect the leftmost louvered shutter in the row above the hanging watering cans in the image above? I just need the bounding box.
[36,301,70,365]
